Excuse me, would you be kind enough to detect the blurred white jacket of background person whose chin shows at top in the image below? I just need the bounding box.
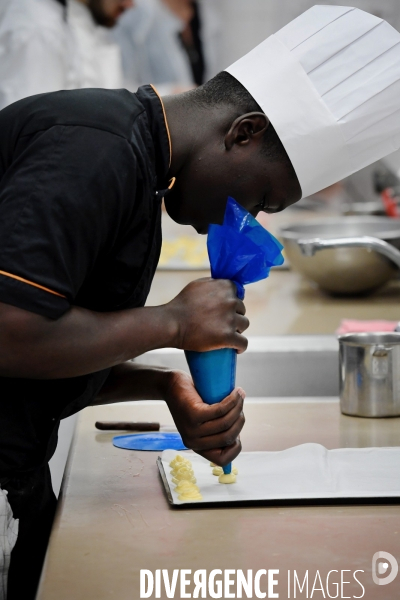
[67,0,124,89]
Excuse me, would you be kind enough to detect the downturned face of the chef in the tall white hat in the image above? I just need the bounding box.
[165,131,301,234]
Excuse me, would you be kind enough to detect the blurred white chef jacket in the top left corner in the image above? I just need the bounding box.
[0,0,79,109]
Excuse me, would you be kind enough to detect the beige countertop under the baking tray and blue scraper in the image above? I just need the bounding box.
[38,398,400,600]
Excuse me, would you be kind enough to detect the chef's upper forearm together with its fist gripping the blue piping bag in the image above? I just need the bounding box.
[0,279,249,379]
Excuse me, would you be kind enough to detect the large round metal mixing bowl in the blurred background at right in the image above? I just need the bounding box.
[279,217,400,295]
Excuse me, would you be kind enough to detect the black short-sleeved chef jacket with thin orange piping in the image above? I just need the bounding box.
[0,86,170,496]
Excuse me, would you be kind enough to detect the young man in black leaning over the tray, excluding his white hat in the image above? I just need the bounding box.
[0,73,300,597]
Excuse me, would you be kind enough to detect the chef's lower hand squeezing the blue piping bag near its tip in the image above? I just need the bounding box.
[164,371,245,466]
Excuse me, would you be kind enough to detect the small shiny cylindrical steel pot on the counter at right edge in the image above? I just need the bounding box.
[339,333,400,417]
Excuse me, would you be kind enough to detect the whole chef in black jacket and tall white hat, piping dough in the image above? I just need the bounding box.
[0,6,400,599]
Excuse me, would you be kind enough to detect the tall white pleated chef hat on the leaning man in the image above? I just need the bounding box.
[226,6,400,196]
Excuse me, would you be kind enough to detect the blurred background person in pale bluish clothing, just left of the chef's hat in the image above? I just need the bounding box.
[114,0,220,95]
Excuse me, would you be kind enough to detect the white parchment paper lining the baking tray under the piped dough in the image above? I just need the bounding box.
[161,444,400,505]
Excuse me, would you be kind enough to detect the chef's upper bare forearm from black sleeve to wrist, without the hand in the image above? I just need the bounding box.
[0,304,176,379]
